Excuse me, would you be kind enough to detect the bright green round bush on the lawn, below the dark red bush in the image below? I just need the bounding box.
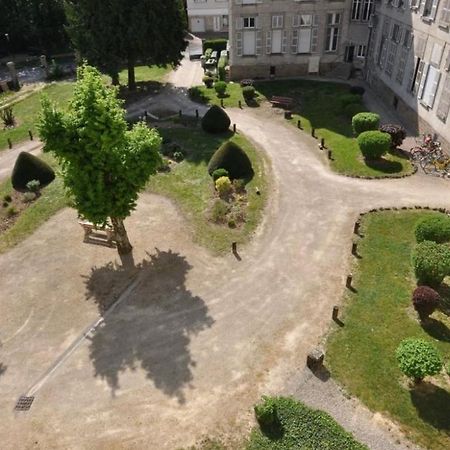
[395,338,442,382]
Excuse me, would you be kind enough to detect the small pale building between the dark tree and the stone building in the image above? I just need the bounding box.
[187,0,229,34]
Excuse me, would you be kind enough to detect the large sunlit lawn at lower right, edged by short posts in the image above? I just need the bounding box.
[327,211,450,450]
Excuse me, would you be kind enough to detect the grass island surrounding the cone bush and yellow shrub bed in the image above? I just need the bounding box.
[148,128,267,253]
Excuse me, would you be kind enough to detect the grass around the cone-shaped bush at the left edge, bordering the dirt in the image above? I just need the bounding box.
[0,154,69,253]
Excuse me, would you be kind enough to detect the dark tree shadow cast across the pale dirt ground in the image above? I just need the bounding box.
[86,249,214,403]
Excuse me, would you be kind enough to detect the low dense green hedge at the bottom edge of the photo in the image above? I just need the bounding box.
[246,397,367,450]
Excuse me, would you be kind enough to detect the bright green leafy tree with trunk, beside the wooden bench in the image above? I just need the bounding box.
[38,65,161,254]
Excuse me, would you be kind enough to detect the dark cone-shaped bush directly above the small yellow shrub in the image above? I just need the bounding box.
[208,141,253,180]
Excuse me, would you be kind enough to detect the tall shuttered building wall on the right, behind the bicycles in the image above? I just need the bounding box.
[366,0,450,148]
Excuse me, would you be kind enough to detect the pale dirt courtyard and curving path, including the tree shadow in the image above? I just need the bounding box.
[0,108,450,449]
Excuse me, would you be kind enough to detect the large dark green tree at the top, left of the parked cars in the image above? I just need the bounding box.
[66,0,186,89]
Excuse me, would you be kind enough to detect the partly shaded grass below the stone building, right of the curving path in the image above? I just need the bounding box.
[251,80,413,177]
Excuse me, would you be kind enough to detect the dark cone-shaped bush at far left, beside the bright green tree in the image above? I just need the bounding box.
[11,152,55,191]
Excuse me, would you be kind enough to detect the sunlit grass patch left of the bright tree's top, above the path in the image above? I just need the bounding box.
[0,81,74,154]
